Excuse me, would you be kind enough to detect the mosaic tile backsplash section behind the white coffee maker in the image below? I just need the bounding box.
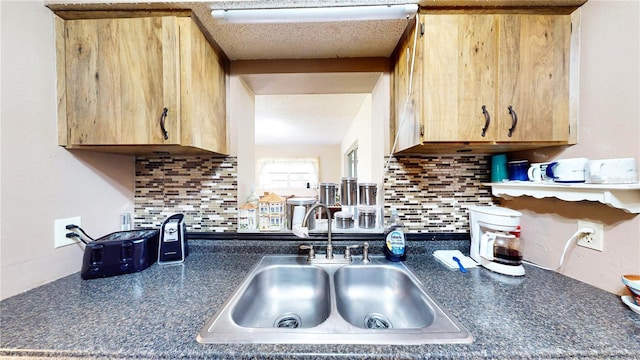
[383,155,494,233]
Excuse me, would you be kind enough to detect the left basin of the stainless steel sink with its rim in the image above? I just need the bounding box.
[197,255,340,344]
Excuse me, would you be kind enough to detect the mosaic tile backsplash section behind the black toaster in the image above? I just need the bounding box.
[134,156,238,232]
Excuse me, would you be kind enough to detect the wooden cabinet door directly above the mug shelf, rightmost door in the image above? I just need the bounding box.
[496,15,571,142]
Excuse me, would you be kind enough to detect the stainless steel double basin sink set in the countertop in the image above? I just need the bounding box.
[197,255,473,344]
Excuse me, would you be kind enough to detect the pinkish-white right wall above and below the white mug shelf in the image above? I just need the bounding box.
[510,0,640,293]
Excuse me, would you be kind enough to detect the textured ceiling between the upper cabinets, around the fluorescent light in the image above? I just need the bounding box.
[50,0,415,61]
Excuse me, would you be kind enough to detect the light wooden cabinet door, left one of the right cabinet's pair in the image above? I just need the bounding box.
[422,14,498,142]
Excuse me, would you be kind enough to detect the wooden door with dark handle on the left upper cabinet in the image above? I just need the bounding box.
[65,17,179,145]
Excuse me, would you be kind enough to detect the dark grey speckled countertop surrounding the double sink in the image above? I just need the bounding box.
[0,240,640,359]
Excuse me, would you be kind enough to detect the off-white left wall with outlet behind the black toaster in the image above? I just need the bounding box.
[0,1,135,299]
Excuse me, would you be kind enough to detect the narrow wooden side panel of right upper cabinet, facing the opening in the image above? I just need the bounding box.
[392,15,422,151]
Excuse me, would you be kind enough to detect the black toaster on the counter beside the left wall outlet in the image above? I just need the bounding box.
[80,230,160,280]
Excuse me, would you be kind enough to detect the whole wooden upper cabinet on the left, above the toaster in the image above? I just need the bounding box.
[58,16,227,154]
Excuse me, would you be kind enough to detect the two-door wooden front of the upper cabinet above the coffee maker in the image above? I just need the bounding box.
[394,14,571,152]
